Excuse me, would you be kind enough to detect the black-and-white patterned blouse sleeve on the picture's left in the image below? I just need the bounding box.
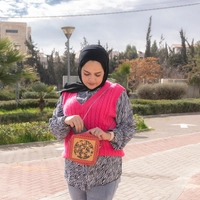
[49,96,70,140]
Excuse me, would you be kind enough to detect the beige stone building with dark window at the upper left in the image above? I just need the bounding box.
[0,21,31,53]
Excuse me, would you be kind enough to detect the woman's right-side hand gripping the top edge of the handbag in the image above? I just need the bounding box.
[88,127,114,141]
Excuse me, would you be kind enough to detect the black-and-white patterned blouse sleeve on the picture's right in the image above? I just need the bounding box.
[111,91,136,149]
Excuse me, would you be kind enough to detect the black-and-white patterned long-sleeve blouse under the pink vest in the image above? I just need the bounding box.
[49,91,135,191]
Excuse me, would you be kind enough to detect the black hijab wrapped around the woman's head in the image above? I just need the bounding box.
[61,44,109,93]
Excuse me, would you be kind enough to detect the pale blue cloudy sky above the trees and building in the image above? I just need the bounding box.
[0,0,200,55]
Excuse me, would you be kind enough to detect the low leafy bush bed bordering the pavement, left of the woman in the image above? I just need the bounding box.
[0,122,55,145]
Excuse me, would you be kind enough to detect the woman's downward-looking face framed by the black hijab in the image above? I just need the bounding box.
[81,60,104,90]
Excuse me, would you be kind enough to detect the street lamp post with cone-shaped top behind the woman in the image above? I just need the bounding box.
[61,26,75,83]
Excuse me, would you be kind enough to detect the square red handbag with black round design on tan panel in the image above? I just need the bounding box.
[69,132,100,165]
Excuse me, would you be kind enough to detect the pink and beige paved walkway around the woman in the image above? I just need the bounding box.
[0,113,200,200]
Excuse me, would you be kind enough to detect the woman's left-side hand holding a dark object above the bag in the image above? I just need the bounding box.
[65,115,84,133]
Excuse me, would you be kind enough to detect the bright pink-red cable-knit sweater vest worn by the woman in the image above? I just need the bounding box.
[62,81,125,158]
